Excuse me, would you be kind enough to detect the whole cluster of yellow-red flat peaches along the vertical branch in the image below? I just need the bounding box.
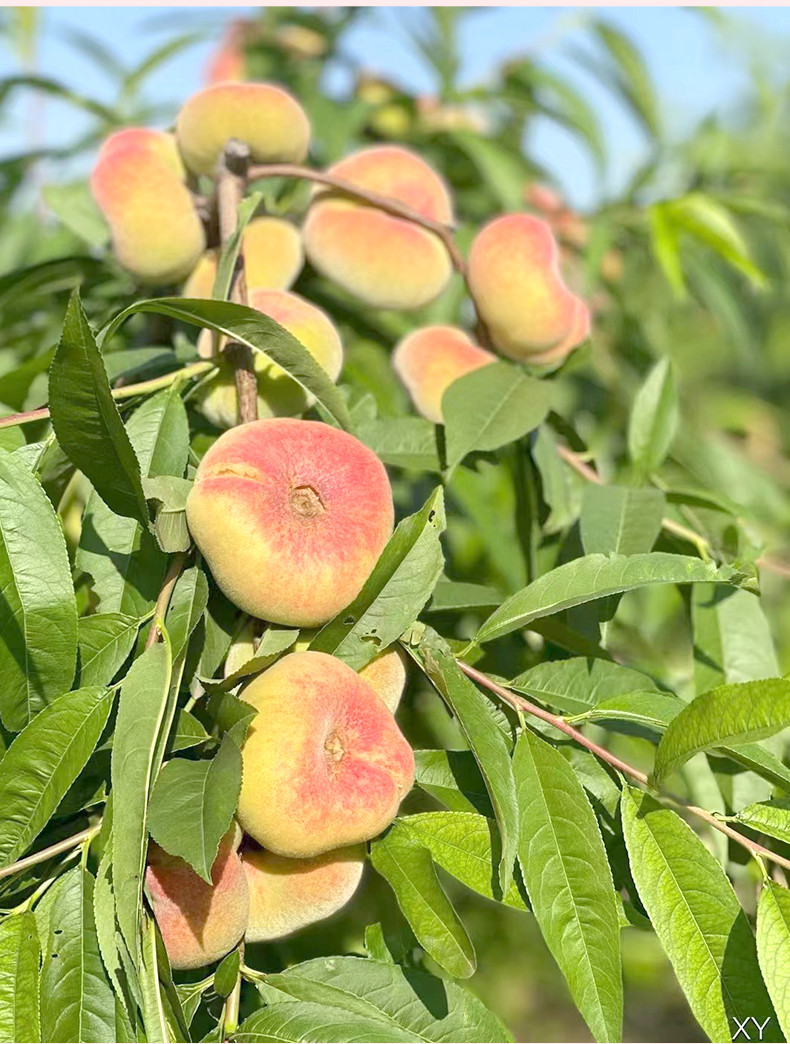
[92,75,589,968]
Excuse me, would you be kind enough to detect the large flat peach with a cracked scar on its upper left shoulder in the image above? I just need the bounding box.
[187,418,394,627]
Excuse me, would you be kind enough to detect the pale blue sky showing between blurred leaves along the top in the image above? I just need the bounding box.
[0,6,790,208]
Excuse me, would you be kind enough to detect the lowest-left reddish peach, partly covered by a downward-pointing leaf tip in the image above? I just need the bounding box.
[145,825,249,969]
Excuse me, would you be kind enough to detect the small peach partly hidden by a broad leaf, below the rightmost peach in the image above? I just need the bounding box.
[392,326,496,424]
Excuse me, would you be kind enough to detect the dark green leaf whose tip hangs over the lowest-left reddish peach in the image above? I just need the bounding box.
[148,736,241,884]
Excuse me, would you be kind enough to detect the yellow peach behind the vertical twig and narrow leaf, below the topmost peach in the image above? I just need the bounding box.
[183,217,305,298]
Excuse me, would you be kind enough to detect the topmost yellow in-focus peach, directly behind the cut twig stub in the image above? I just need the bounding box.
[175,84,310,174]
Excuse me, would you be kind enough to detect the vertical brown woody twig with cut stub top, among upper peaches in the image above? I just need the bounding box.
[217,139,258,424]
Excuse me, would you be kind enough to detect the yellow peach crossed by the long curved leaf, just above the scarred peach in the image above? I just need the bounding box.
[197,290,343,428]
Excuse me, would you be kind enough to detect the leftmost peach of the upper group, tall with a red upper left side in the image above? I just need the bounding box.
[91,140,206,283]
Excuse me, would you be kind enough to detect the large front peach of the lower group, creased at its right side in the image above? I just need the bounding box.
[238,653,414,858]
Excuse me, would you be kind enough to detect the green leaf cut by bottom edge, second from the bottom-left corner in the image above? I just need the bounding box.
[41,867,117,1044]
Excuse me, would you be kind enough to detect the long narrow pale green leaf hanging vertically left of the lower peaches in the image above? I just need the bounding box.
[112,636,172,965]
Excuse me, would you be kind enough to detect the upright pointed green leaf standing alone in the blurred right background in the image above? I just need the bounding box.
[628,356,678,475]
